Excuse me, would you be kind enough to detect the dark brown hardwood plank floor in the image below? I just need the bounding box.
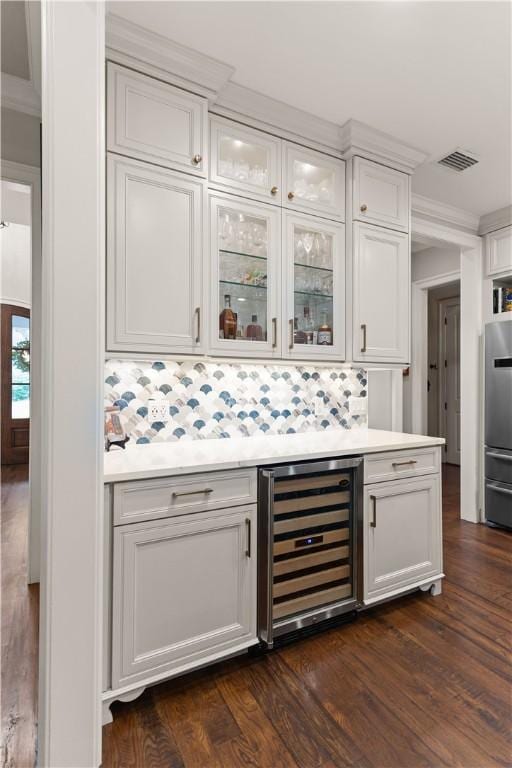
[2,466,512,768]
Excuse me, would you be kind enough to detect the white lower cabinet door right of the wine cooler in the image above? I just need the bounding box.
[364,474,442,604]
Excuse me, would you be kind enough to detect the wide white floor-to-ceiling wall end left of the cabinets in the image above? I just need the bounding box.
[38,0,105,766]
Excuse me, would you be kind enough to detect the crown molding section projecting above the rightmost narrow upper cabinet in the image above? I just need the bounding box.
[339,120,429,174]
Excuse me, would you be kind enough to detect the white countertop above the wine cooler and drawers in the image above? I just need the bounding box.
[104,429,444,483]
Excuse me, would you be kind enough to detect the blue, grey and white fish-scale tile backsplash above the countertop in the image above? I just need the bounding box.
[105,360,367,444]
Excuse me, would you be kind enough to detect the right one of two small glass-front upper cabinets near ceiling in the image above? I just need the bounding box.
[283,141,345,221]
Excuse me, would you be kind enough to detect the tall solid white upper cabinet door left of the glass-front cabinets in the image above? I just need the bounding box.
[107,155,206,360]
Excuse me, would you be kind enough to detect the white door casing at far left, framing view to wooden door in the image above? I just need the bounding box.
[0,159,42,584]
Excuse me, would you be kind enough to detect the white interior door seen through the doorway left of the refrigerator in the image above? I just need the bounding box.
[440,298,460,465]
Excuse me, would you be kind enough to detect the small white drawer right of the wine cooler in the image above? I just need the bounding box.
[364,445,441,484]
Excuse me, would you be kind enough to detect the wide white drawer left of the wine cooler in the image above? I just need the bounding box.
[114,469,257,525]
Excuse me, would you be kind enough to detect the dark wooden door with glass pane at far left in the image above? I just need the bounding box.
[1,304,30,464]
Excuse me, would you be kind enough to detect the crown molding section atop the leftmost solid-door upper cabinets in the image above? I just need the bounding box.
[106,13,235,98]
